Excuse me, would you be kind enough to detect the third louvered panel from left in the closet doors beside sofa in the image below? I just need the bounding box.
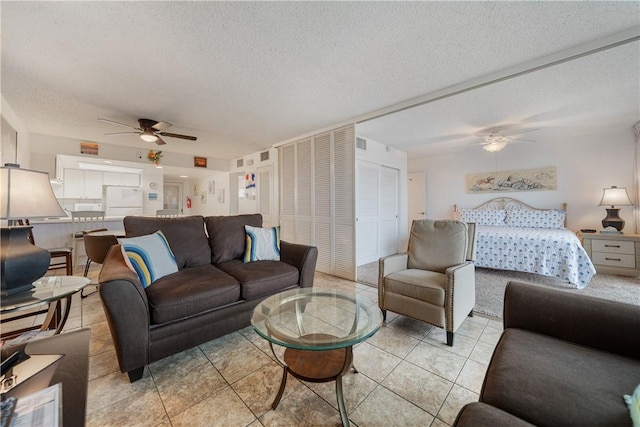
[313,132,333,274]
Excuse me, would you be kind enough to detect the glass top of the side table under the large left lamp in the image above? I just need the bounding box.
[0,276,91,313]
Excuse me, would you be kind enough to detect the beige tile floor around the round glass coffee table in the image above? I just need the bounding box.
[2,266,502,427]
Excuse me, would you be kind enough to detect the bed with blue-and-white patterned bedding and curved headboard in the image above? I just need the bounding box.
[454,197,596,289]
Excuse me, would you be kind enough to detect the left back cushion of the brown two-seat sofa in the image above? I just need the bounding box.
[124,216,211,269]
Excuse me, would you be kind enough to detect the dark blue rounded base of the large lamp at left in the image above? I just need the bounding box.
[0,226,51,296]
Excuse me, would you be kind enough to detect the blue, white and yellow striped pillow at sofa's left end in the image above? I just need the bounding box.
[120,231,178,288]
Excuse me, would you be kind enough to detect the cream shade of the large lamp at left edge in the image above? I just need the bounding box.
[0,167,67,220]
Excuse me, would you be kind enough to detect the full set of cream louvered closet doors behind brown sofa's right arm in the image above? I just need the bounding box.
[278,125,355,280]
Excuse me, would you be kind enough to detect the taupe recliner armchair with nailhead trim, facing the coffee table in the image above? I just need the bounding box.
[378,219,476,346]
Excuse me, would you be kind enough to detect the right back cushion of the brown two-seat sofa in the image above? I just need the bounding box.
[208,214,262,264]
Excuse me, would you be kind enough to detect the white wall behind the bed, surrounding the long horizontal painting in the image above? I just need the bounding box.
[408,124,636,232]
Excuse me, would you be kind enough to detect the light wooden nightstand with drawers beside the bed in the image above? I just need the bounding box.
[578,232,640,276]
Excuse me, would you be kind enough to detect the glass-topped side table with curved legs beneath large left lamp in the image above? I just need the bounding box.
[0,276,91,339]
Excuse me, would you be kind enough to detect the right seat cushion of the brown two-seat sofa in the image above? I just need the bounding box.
[217,259,300,300]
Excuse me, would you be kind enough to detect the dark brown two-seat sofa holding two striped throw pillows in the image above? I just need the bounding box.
[99,214,318,381]
